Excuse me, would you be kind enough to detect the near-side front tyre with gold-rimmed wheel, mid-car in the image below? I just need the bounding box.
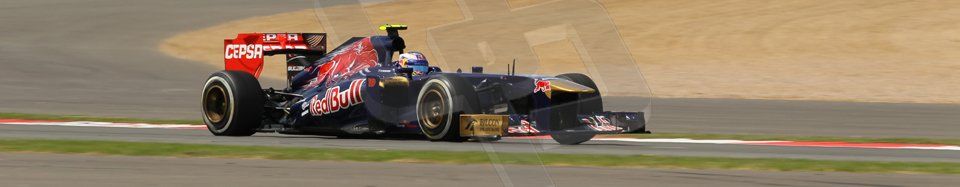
[416,75,479,141]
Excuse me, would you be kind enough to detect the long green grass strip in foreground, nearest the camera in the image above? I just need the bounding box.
[0,139,960,174]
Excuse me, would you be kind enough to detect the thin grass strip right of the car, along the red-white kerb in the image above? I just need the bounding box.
[604,133,960,145]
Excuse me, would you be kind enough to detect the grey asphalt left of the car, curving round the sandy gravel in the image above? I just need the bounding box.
[0,0,313,118]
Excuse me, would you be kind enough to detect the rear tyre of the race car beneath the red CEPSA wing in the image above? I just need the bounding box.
[201,71,265,136]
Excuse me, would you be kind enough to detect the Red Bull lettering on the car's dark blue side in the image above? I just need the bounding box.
[310,79,365,116]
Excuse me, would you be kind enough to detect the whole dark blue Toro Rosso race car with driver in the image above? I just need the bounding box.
[201,25,646,144]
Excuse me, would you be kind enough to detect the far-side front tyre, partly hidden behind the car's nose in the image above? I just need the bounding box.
[550,73,603,145]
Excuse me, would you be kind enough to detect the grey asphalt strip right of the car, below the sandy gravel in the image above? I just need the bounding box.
[604,97,960,138]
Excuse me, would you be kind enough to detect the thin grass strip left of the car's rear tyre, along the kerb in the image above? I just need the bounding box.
[0,113,203,124]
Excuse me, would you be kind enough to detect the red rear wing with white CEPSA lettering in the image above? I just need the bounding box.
[223,33,327,81]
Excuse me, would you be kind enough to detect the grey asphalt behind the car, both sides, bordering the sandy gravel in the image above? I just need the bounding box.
[0,0,960,138]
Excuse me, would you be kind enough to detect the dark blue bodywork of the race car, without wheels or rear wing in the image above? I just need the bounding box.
[261,36,646,136]
